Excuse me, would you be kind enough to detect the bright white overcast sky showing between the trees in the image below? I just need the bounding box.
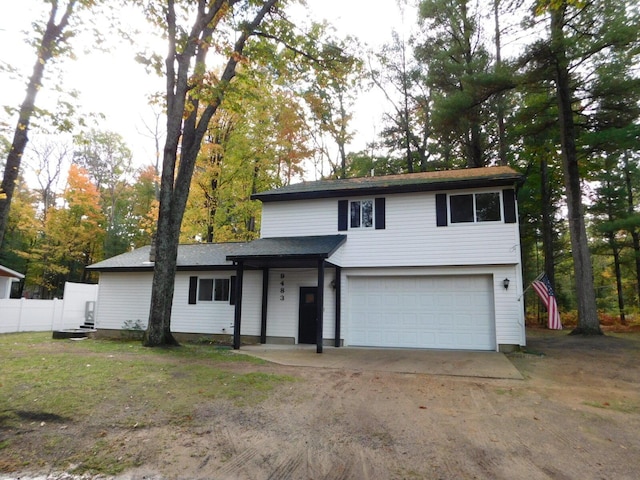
[0,0,415,178]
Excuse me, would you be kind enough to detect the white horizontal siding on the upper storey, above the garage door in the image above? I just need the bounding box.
[262,192,520,267]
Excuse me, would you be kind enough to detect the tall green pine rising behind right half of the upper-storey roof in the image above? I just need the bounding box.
[416,0,500,167]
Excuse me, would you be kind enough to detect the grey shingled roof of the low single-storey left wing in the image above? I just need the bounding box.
[87,243,243,272]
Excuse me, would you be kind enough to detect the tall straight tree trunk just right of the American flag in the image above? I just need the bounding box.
[551,4,602,335]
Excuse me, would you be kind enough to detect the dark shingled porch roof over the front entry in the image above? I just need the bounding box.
[227,235,347,268]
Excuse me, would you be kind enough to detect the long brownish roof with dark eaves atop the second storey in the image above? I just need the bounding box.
[251,167,522,202]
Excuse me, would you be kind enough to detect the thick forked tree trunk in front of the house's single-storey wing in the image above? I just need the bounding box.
[143,0,278,347]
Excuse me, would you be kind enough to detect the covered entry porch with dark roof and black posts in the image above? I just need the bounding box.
[227,235,347,353]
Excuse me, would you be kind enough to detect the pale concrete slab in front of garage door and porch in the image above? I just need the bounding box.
[235,345,523,380]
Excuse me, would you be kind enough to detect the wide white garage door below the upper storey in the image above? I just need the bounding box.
[347,275,496,350]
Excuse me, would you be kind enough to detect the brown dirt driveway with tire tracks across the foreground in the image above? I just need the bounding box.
[0,331,640,480]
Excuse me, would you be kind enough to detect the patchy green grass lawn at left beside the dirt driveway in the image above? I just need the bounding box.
[0,332,294,474]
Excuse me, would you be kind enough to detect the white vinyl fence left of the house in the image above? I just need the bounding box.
[0,282,98,333]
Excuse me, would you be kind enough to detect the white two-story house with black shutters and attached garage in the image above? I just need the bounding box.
[86,167,525,352]
